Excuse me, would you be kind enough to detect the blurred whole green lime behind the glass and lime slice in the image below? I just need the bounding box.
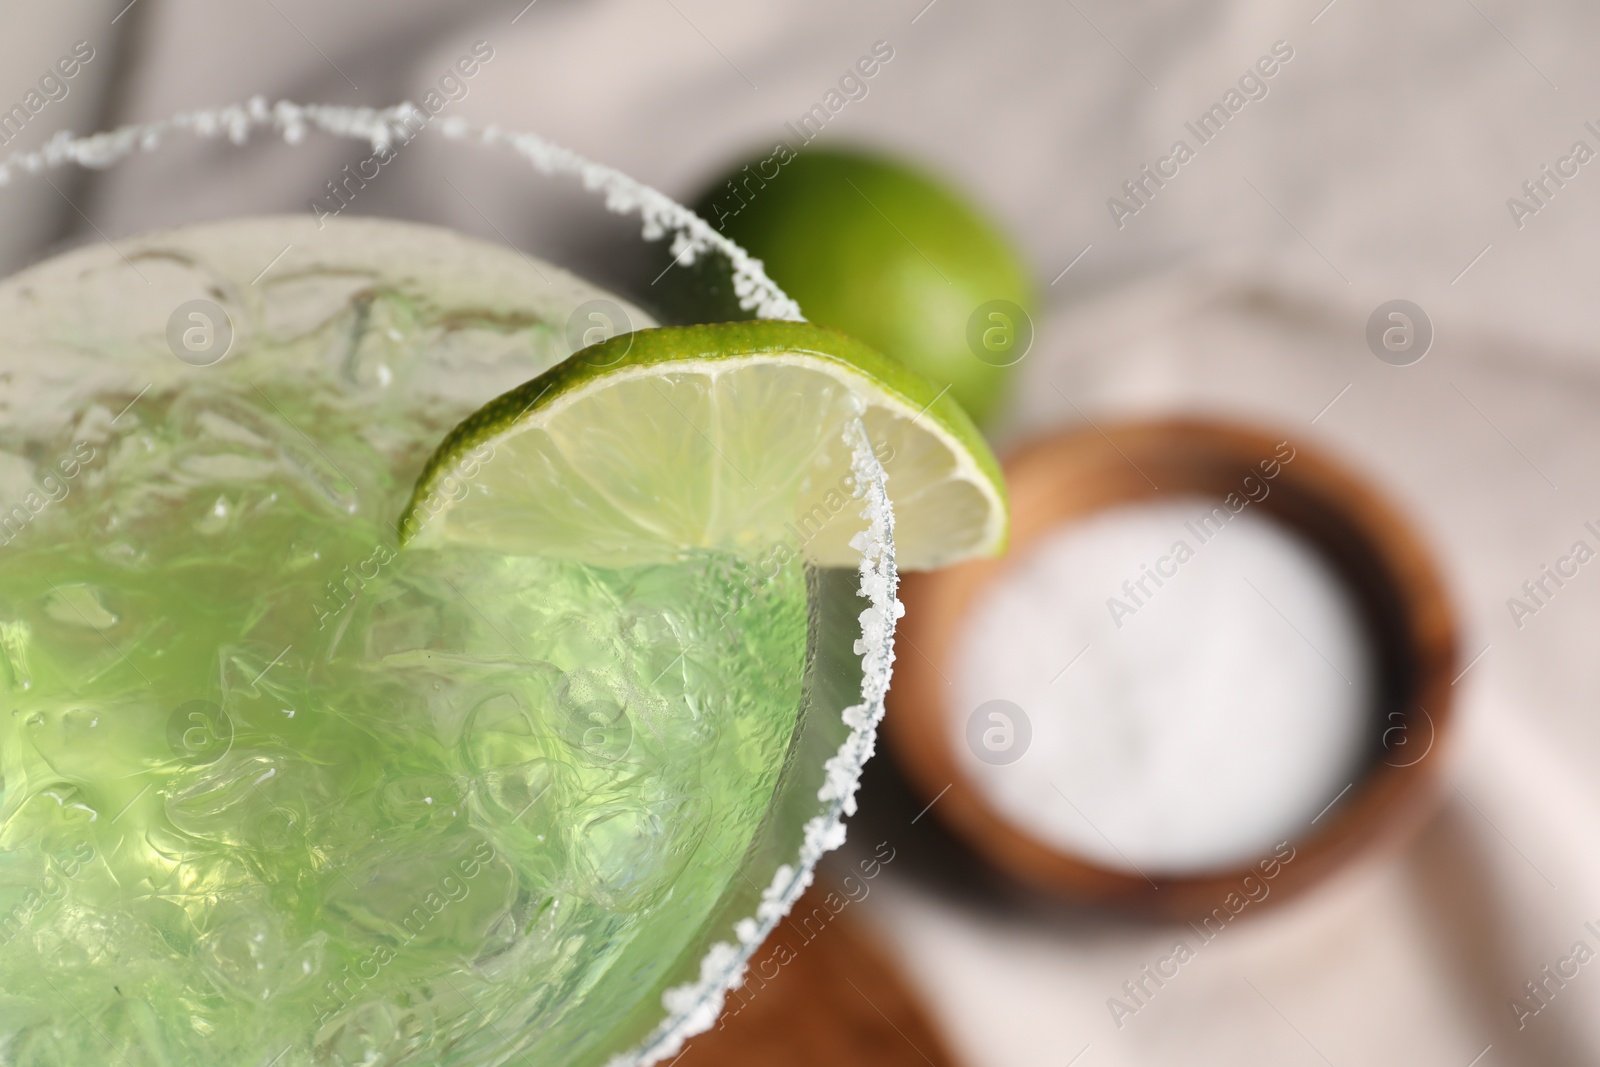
[696,149,1032,422]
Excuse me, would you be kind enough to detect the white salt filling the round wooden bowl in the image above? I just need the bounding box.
[949,496,1378,875]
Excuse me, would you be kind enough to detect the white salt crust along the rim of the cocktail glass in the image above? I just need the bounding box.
[0,96,904,1067]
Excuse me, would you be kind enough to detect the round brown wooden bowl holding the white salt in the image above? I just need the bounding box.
[886,419,1456,920]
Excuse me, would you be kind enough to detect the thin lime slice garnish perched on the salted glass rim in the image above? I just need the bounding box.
[400,322,1006,569]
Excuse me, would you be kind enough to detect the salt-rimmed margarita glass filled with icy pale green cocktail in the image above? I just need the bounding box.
[0,101,898,1067]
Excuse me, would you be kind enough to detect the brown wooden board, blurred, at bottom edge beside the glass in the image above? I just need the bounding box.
[675,888,957,1067]
